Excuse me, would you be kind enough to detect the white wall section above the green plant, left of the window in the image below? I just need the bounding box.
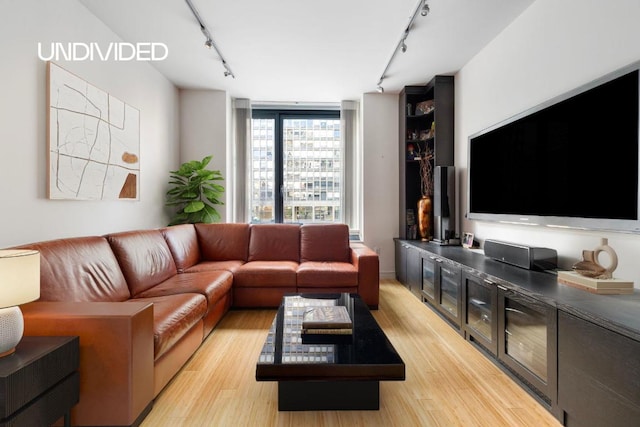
[180,89,232,222]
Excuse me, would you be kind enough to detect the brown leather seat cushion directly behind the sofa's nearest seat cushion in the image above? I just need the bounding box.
[137,270,233,312]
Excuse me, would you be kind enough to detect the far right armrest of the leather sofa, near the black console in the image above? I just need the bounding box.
[351,243,380,310]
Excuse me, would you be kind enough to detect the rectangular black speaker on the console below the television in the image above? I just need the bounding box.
[484,239,558,271]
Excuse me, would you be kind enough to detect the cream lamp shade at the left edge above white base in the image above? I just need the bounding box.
[0,249,40,308]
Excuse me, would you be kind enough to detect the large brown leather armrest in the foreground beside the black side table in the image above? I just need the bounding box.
[20,301,154,426]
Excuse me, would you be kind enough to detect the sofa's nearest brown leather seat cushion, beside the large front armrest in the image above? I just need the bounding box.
[130,293,207,360]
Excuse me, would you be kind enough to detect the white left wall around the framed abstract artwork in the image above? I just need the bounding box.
[0,0,178,247]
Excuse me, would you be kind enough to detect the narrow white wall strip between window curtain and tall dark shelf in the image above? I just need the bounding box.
[362,93,400,278]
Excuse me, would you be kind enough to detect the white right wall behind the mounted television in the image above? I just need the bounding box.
[455,0,640,287]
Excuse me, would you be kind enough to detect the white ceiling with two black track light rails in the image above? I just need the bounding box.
[81,0,534,102]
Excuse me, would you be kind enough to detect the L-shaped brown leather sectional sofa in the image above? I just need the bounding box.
[15,223,379,426]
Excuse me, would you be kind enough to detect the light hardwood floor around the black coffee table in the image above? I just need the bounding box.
[142,280,560,427]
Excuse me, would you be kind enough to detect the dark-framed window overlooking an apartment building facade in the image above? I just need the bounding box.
[249,109,344,223]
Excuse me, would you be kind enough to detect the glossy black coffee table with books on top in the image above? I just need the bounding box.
[256,294,405,411]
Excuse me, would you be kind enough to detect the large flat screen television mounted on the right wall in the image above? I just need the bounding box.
[467,63,640,233]
